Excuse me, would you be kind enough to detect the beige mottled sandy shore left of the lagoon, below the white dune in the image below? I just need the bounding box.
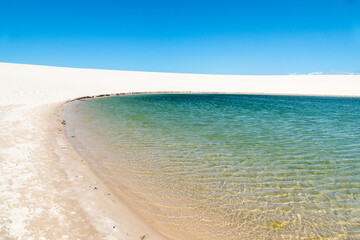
[0,103,166,239]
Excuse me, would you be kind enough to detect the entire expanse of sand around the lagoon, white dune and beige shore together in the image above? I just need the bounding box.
[0,63,360,239]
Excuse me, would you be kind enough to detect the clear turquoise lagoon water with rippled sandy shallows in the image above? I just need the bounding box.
[64,94,360,239]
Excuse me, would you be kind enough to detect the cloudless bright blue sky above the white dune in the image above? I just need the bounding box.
[0,0,360,74]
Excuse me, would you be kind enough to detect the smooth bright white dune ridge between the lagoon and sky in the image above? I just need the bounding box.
[0,63,360,104]
